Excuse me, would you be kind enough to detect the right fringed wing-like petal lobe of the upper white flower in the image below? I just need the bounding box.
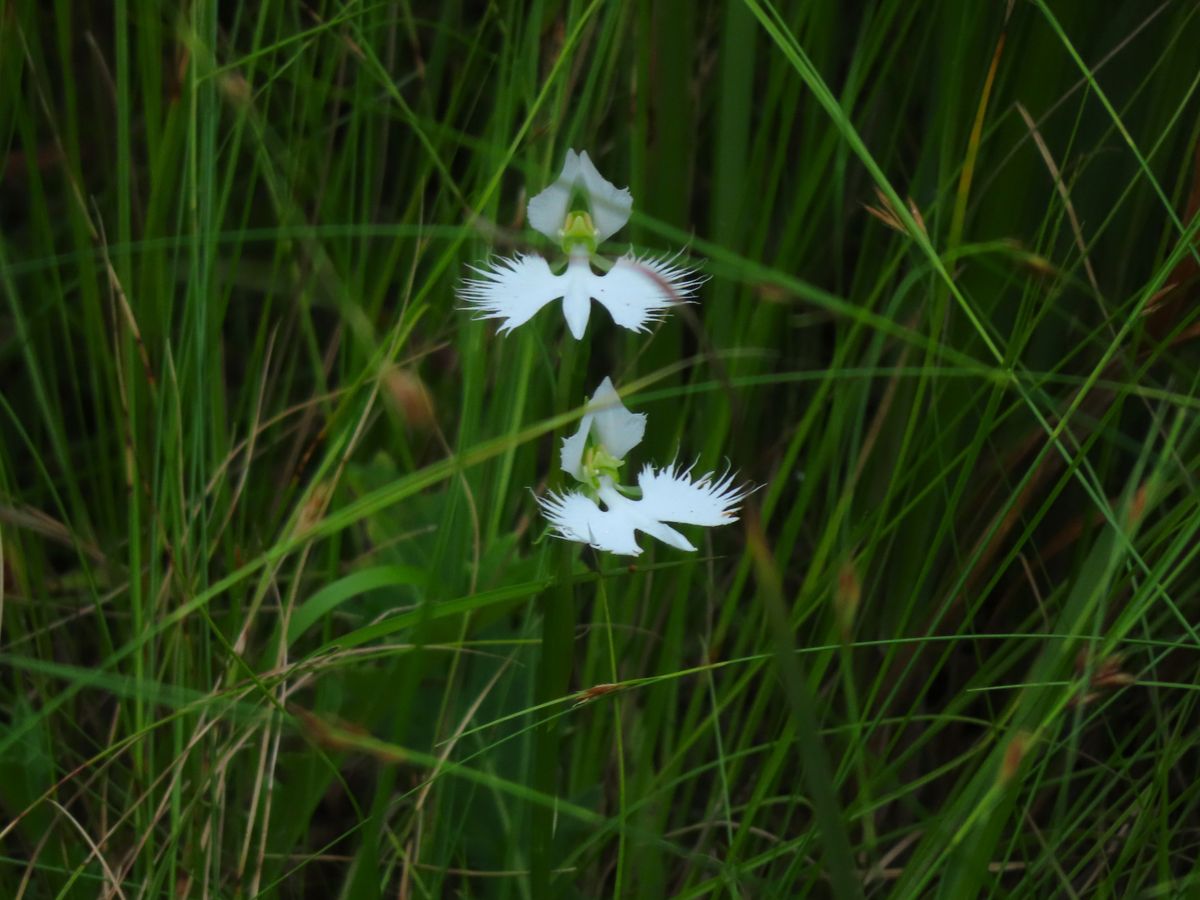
[592,254,707,331]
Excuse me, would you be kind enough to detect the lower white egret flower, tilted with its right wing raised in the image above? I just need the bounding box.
[538,378,750,556]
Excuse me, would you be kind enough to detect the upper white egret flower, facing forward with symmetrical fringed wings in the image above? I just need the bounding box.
[458,150,704,340]
